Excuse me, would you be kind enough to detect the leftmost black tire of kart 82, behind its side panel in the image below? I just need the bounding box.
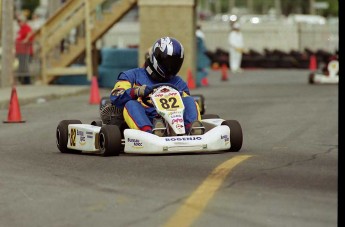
[56,120,81,154]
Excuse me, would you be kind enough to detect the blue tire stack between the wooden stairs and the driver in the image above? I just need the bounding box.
[98,48,138,88]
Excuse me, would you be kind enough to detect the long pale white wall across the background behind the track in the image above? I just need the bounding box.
[102,22,339,52]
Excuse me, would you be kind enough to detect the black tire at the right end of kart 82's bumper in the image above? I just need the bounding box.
[222,120,243,151]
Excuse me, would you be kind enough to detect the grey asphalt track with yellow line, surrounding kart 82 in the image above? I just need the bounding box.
[0,70,339,227]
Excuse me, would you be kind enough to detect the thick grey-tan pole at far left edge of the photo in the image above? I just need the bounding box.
[0,0,14,87]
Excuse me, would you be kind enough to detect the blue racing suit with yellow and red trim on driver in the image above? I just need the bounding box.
[110,68,201,132]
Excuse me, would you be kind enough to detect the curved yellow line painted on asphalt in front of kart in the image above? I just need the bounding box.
[164,155,252,227]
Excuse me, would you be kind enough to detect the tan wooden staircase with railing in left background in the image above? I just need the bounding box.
[35,0,137,84]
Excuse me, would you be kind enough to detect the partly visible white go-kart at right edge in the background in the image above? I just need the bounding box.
[308,60,339,84]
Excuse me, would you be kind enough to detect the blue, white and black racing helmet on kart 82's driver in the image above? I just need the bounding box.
[145,37,184,82]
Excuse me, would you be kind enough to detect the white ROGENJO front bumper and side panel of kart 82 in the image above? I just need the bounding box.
[67,118,231,154]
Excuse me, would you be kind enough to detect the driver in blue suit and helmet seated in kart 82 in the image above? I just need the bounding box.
[110,37,205,136]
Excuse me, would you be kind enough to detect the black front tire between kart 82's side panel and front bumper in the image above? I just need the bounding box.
[98,125,123,156]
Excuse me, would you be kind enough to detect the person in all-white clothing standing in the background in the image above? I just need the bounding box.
[228,22,244,73]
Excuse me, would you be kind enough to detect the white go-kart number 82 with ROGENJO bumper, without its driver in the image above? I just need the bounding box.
[56,84,243,156]
